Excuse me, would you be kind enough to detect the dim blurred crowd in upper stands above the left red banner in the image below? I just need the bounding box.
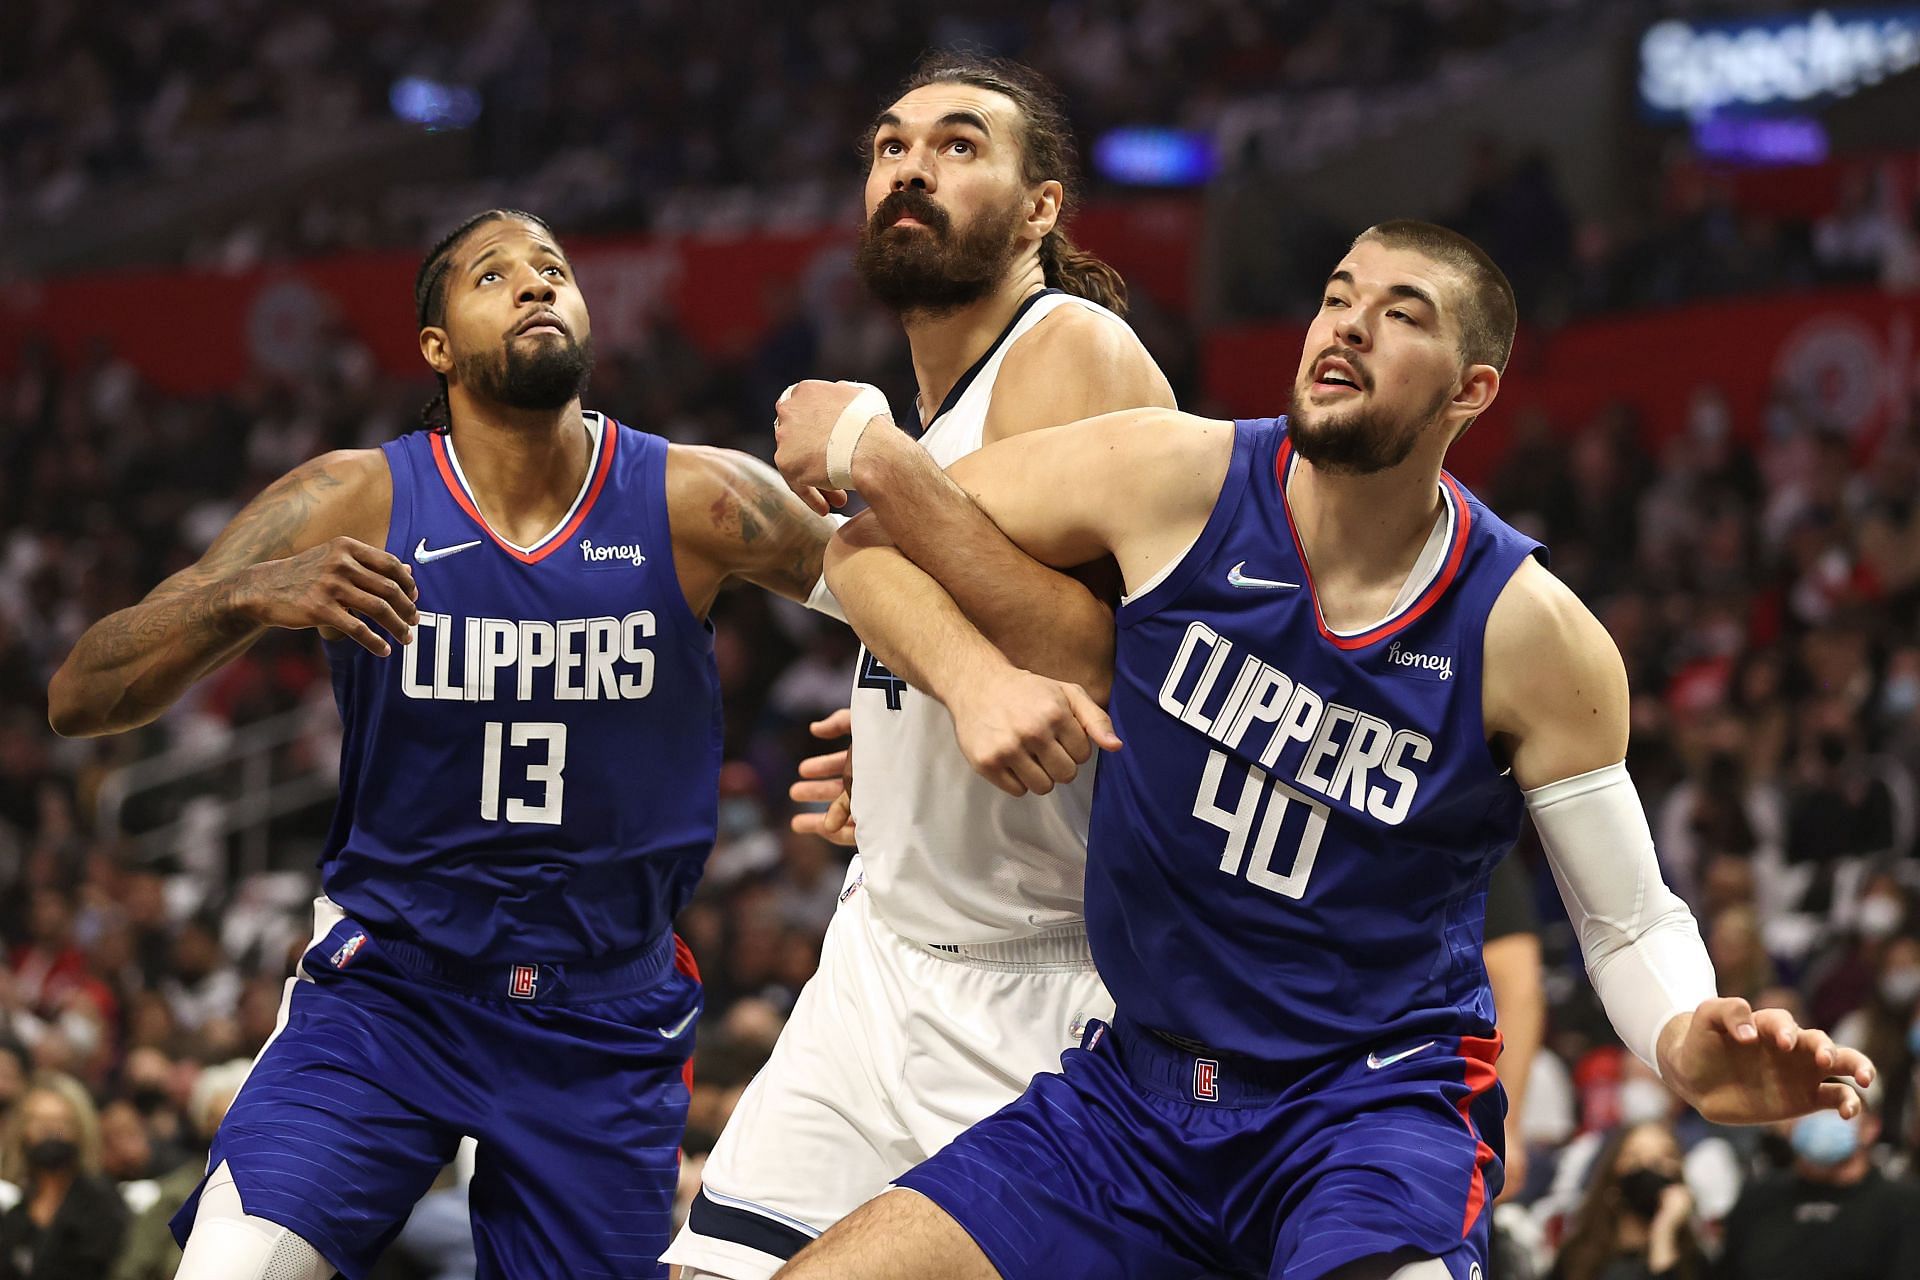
[0,0,1578,265]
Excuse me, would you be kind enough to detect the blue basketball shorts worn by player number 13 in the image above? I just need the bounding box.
[173,905,701,1280]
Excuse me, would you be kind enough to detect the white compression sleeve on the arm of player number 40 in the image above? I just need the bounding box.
[1524,762,1718,1073]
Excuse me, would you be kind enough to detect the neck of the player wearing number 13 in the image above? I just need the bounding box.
[447,401,593,545]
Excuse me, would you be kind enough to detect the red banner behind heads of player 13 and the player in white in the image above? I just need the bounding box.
[0,198,1200,393]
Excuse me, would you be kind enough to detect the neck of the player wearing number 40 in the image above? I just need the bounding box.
[1286,451,1442,583]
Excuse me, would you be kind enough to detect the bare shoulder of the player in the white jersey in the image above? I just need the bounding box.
[987,301,1173,439]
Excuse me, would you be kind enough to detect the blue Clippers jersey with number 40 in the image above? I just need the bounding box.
[1087,418,1540,1061]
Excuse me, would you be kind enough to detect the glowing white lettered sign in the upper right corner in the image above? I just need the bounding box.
[1640,8,1920,117]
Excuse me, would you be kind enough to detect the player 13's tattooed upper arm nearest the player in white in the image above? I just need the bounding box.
[666,445,833,618]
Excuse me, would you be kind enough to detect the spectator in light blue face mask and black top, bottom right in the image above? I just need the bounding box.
[1715,1088,1920,1280]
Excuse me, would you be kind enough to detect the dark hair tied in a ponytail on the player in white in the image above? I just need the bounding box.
[862,50,1127,315]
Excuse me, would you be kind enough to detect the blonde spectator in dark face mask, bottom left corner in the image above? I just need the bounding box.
[0,1075,127,1280]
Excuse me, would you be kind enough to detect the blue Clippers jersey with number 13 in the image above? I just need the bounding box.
[321,415,720,963]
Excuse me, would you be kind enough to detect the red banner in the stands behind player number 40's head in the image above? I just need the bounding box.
[1204,290,1920,480]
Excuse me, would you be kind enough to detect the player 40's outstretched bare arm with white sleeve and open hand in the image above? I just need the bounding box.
[1484,560,1874,1125]
